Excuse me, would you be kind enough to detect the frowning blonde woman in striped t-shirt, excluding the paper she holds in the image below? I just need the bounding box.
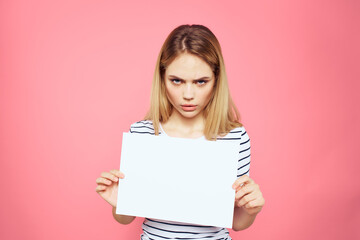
[96,25,265,240]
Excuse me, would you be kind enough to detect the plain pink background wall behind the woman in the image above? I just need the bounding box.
[0,0,360,240]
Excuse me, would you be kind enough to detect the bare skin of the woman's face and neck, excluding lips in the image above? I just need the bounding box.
[162,54,215,138]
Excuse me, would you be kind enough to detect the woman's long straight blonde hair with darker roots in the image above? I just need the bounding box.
[144,24,242,140]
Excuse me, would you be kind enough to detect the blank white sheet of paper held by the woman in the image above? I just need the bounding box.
[116,133,238,228]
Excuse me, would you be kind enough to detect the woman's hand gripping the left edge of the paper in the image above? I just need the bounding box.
[95,169,125,207]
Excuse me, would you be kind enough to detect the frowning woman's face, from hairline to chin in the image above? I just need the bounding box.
[165,53,215,118]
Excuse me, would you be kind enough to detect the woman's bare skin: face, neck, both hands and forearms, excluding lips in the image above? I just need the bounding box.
[96,53,265,231]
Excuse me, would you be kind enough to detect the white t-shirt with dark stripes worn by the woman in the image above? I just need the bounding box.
[130,120,250,240]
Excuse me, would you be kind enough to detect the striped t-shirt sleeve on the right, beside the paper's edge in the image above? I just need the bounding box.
[237,126,250,177]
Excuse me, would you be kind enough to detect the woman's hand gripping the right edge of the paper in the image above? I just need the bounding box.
[232,175,265,215]
